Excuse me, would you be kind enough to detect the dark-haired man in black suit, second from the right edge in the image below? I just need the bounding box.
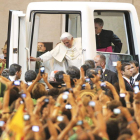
[121,62,133,92]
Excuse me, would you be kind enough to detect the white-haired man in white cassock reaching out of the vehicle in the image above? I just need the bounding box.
[30,32,83,71]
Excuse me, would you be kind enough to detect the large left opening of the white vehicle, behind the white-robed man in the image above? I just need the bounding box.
[30,11,81,73]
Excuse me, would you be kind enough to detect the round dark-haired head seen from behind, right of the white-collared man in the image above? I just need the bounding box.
[25,70,37,82]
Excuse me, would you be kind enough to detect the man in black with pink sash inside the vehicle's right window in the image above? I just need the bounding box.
[94,18,122,53]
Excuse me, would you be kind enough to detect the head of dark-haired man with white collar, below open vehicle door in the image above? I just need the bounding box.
[9,64,22,80]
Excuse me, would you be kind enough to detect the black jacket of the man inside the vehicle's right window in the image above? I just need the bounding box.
[96,29,122,53]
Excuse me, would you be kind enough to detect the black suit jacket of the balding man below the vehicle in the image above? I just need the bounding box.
[103,69,118,84]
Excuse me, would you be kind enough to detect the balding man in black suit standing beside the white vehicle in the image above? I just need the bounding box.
[94,54,118,84]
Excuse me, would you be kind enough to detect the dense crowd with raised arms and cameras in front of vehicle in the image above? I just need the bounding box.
[0,54,140,140]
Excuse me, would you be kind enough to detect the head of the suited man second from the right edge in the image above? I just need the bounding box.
[121,62,132,79]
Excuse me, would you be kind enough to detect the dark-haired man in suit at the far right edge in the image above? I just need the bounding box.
[129,60,140,84]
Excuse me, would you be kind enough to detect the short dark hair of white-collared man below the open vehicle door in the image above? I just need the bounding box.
[9,64,21,76]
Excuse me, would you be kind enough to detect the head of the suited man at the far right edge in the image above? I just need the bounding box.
[129,60,139,76]
